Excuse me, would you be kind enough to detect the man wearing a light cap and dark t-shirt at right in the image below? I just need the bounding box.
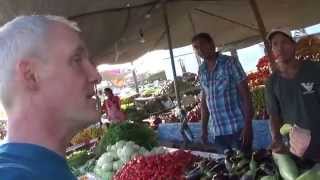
[266,29,320,161]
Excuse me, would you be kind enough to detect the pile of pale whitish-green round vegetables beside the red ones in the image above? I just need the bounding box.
[94,141,166,180]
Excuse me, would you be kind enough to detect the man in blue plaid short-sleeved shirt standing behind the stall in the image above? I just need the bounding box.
[192,33,253,153]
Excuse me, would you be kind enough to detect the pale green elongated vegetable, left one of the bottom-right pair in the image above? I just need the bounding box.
[272,153,299,180]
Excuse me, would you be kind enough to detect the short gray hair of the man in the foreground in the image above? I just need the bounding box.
[0,15,80,106]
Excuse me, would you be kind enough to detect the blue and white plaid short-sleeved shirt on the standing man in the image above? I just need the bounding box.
[199,54,246,136]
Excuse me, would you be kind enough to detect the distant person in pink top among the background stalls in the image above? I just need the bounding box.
[102,88,126,123]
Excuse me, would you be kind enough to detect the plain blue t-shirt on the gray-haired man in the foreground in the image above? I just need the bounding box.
[0,143,76,180]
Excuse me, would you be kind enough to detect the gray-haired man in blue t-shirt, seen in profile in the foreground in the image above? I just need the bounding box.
[0,15,101,180]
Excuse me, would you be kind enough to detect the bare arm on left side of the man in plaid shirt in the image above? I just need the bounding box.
[200,91,209,143]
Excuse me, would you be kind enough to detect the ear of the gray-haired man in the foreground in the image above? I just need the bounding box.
[16,60,39,91]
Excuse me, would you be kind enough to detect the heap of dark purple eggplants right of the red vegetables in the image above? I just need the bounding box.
[186,149,279,180]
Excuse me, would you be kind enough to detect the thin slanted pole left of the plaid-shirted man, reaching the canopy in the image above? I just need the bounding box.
[161,1,181,109]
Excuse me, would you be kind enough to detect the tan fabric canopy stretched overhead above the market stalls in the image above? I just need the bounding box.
[0,0,320,64]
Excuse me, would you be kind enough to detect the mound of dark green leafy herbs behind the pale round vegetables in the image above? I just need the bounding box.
[96,122,158,155]
